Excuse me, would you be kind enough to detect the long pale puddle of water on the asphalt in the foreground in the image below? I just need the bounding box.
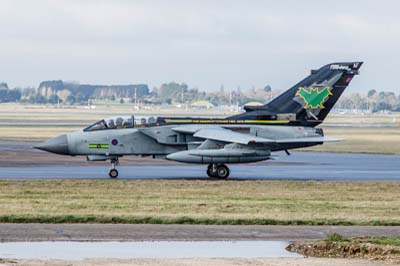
[0,241,302,260]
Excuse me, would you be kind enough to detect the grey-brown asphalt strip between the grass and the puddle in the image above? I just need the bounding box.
[0,224,400,242]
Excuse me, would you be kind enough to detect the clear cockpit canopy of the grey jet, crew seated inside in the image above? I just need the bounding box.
[83,115,157,131]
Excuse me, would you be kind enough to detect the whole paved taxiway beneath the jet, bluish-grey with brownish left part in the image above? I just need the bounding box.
[0,141,400,181]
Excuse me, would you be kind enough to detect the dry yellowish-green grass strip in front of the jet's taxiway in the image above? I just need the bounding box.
[0,179,400,225]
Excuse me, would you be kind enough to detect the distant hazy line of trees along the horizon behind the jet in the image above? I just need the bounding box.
[0,81,400,112]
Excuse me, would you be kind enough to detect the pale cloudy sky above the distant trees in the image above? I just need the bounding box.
[0,0,400,92]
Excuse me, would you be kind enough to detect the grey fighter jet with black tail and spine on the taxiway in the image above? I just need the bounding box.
[35,62,362,179]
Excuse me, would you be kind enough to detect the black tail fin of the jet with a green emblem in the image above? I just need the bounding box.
[239,62,363,126]
